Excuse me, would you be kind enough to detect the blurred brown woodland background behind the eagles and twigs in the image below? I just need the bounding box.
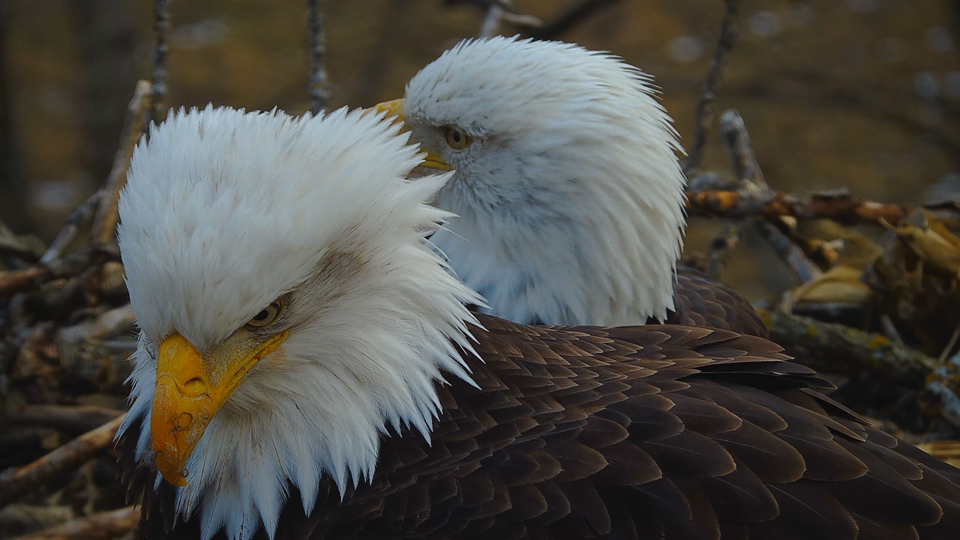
[0,0,960,299]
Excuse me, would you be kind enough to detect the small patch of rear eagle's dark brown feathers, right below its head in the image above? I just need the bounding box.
[664,266,768,337]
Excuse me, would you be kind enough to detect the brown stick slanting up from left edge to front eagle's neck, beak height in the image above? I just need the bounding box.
[0,416,124,508]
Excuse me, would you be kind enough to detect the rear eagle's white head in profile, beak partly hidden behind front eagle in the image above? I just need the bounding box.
[378,37,685,325]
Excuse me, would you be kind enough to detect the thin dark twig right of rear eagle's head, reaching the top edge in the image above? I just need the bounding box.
[683,0,740,176]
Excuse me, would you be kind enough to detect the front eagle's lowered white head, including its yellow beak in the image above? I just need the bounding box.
[119,107,479,539]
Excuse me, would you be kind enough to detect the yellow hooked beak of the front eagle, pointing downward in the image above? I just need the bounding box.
[150,331,289,486]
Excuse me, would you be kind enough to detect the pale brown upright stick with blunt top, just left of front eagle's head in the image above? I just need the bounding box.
[90,81,156,248]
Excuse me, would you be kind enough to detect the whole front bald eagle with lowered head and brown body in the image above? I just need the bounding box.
[119,108,960,540]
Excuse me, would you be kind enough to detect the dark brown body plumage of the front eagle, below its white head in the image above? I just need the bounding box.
[121,316,960,540]
